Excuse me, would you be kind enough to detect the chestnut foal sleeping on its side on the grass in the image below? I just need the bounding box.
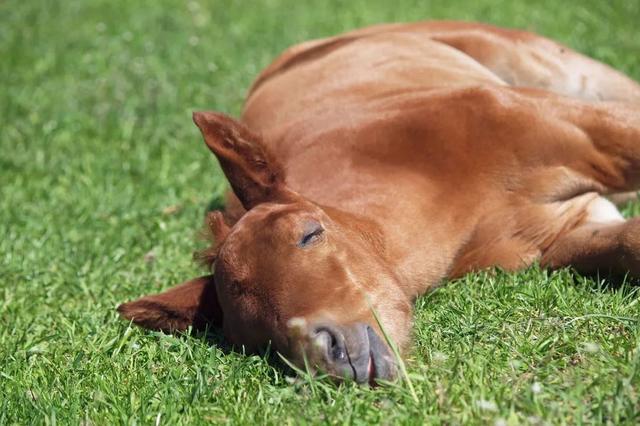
[118,22,640,383]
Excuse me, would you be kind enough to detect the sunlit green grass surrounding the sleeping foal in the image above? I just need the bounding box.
[0,0,640,425]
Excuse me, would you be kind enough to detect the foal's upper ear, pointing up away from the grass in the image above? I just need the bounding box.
[193,112,296,210]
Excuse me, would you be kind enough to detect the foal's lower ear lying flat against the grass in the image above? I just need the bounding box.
[118,275,222,332]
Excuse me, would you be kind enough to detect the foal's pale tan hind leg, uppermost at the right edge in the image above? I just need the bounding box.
[426,23,640,103]
